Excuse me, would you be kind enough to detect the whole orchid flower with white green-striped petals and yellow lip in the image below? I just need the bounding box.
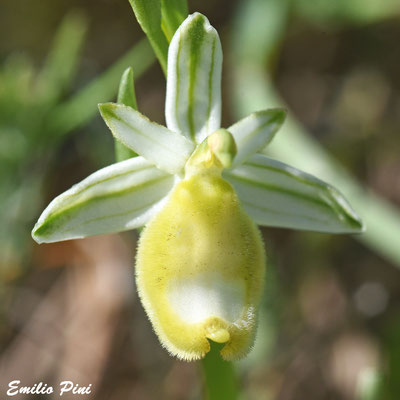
[32,13,362,360]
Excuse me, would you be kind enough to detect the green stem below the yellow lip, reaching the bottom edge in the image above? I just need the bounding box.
[201,342,238,400]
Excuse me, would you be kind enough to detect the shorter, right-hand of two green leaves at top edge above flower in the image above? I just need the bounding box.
[161,0,189,42]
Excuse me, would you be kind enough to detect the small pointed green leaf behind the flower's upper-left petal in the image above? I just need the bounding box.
[115,67,137,161]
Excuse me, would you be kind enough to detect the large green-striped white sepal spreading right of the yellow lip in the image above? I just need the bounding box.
[225,154,363,233]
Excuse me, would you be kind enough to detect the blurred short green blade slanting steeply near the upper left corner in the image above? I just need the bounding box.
[37,12,87,102]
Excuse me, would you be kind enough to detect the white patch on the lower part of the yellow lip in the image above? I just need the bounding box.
[168,271,245,324]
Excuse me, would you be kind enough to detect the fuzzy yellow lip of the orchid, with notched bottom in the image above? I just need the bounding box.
[136,169,265,360]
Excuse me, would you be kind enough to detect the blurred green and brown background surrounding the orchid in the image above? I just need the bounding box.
[0,0,400,400]
